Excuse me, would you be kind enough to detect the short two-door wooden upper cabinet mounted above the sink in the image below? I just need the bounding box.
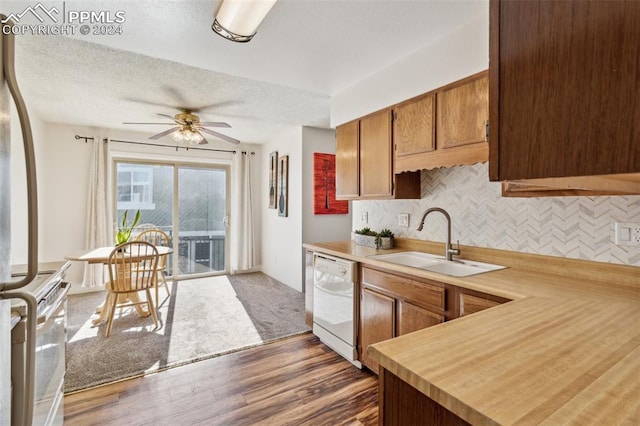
[393,71,489,173]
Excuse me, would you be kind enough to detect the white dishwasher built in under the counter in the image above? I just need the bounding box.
[313,253,362,368]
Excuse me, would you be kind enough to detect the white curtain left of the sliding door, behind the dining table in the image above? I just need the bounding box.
[82,137,113,287]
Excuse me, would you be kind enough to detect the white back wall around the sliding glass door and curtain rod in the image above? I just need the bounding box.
[23,123,261,290]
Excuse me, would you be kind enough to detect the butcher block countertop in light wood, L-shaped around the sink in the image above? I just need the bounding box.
[304,239,640,425]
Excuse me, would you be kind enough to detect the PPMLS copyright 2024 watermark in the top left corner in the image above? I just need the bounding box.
[2,1,126,35]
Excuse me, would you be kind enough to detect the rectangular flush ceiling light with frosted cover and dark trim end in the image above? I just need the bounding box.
[211,0,276,43]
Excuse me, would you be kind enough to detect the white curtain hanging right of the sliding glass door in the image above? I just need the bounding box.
[230,151,256,274]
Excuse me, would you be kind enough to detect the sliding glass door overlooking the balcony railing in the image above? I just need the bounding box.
[114,160,229,279]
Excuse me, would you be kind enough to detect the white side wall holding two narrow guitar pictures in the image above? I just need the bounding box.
[260,127,303,291]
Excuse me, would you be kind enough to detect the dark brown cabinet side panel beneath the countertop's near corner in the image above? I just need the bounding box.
[378,368,470,426]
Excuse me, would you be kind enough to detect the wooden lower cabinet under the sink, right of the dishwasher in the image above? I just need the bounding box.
[358,267,445,373]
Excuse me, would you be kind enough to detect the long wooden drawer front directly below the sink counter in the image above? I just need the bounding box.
[362,268,445,312]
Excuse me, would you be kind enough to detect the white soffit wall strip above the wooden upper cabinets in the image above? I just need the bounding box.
[331,12,489,127]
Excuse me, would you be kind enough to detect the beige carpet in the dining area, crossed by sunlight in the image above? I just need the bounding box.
[65,273,309,392]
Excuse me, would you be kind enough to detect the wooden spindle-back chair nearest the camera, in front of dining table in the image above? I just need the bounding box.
[105,241,159,337]
